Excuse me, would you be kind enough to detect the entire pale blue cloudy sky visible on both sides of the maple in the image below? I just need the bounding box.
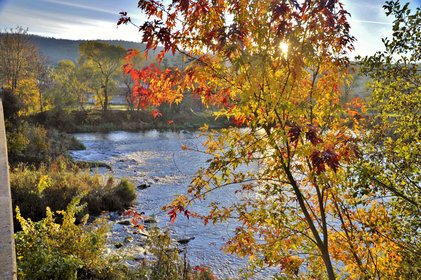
[0,0,421,56]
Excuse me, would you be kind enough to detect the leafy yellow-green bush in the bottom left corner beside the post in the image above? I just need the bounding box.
[15,198,130,279]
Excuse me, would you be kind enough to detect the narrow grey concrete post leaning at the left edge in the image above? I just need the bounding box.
[0,99,17,280]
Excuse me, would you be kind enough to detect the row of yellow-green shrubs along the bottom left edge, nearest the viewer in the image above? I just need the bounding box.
[15,197,215,280]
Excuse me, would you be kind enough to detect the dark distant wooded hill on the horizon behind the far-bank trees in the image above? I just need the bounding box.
[26,35,177,65]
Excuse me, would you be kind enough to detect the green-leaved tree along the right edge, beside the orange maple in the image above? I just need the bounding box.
[358,1,421,279]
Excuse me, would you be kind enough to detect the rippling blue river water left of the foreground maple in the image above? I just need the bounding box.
[72,130,269,279]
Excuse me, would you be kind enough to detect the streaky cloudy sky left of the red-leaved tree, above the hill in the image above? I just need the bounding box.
[0,0,144,41]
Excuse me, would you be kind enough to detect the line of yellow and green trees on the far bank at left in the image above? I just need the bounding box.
[0,27,152,115]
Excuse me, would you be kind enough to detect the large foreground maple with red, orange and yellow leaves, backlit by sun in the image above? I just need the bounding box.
[118,0,408,279]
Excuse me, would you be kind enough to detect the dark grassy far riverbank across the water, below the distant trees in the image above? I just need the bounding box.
[28,110,230,133]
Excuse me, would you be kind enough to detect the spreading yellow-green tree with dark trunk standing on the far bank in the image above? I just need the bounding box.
[79,41,126,111]
